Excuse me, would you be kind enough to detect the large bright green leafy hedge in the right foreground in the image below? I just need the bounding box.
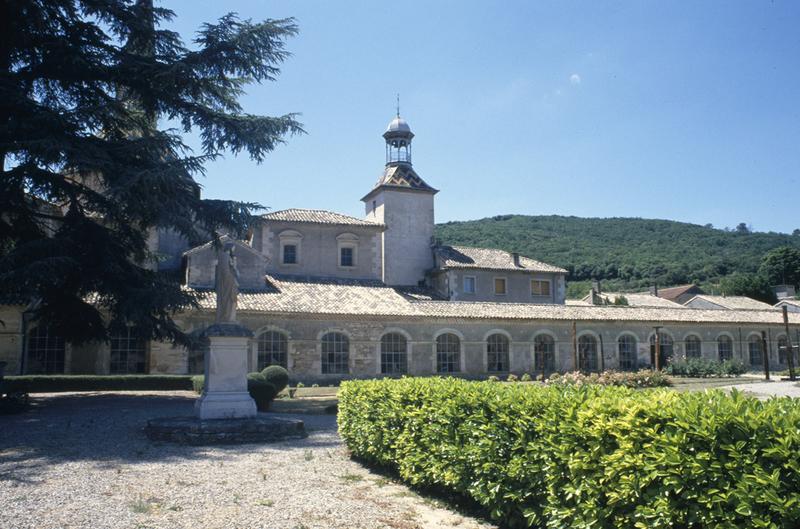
[338,378,800,528]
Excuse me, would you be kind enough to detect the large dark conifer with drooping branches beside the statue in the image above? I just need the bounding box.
[0,0,302,343]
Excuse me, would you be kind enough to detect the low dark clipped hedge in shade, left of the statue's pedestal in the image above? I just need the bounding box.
[0,375,192,393]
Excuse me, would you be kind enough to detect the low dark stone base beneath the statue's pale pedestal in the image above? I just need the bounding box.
[145,415,308,445]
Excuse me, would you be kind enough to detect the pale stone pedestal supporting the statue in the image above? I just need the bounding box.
[194,323,258,420]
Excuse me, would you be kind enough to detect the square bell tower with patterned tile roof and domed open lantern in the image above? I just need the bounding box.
[361,110,438,286]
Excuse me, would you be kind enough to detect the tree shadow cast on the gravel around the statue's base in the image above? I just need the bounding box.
[0,392,340,482]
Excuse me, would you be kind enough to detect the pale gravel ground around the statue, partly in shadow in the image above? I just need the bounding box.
[0,392,493,529]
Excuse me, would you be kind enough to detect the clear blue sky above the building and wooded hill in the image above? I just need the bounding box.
[166,0,800,232]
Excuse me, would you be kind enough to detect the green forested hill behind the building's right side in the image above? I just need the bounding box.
[436,215,800,294]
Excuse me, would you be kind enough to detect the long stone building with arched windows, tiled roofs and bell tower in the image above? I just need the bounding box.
[0,115,800,382]
